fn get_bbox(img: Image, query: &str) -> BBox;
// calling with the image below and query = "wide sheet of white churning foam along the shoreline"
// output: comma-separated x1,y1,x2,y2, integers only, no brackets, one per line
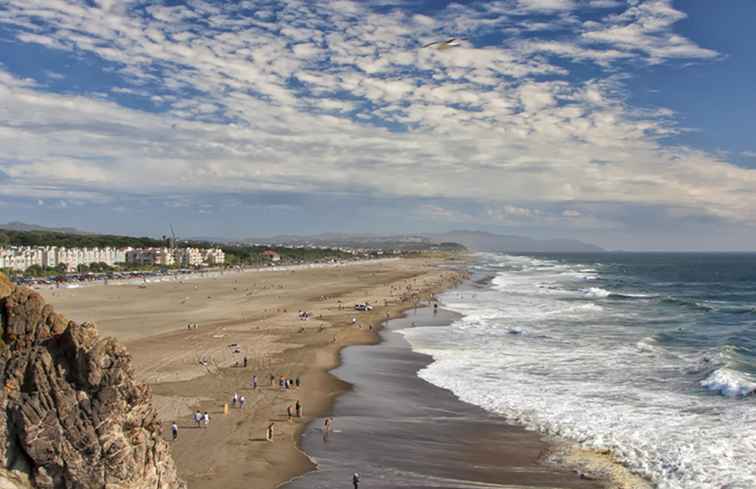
403,257,756,489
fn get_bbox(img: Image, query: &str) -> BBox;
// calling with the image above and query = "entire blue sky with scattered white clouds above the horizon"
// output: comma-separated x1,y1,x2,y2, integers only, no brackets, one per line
0,0,756,250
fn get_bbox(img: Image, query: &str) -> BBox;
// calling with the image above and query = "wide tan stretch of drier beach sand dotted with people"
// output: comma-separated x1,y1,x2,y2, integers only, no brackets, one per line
40,259,460,489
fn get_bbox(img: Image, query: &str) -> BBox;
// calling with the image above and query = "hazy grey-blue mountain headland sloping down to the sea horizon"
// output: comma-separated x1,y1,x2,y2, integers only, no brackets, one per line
425,231,605,253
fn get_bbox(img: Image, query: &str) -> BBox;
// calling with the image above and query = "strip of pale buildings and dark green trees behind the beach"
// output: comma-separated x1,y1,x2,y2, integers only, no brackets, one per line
0,223,464,284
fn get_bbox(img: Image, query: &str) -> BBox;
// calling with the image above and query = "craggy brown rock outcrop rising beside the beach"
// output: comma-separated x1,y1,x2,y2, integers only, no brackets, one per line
0,274,185,489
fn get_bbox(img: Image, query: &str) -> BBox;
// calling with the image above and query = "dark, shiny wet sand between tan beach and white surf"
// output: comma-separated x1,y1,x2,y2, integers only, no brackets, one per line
284,308,603,489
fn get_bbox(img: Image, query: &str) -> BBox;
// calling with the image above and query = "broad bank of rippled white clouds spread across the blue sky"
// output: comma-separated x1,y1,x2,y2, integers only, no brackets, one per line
0,0,756,227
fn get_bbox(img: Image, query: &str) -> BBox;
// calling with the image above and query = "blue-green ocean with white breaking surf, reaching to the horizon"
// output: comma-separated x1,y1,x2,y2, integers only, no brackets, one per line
402,253,756,489
